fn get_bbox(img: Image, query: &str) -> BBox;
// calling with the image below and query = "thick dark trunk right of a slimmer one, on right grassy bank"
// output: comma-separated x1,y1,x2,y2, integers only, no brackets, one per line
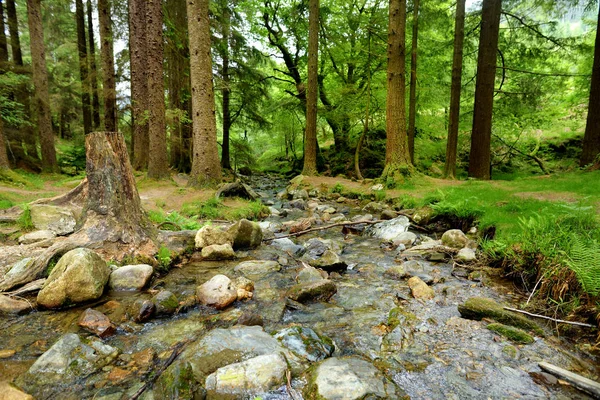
469,0,502,179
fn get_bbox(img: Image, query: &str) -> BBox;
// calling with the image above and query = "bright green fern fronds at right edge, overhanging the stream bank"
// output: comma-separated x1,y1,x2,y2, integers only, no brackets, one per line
567,235,600,296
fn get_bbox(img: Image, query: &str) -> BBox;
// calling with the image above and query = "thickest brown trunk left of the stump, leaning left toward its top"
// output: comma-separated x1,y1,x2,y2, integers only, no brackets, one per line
27,0,58,172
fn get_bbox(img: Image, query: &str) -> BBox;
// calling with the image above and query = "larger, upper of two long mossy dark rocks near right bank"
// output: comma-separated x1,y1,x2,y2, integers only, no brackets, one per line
458,297,544,336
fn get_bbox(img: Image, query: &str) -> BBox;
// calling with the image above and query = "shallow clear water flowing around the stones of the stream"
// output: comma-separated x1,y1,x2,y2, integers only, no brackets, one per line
0,177,597,399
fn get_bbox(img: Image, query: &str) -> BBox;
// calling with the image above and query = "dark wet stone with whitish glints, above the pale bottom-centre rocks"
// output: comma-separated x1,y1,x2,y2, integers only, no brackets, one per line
275,326,335,362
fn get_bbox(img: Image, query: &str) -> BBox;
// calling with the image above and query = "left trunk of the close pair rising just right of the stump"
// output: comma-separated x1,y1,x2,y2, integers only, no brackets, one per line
129,0,150,170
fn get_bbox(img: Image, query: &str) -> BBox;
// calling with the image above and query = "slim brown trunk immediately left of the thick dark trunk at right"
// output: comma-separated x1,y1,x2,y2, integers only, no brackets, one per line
444,0,465,179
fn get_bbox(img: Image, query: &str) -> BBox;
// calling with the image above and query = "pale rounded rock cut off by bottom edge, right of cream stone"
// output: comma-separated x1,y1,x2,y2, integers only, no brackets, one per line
305,357,401,400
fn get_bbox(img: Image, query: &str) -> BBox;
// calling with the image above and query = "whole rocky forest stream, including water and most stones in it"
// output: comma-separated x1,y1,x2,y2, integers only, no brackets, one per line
0,176,598,400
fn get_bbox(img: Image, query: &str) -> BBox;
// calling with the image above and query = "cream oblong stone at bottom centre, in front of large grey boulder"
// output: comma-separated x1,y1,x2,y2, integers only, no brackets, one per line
204,354,287,398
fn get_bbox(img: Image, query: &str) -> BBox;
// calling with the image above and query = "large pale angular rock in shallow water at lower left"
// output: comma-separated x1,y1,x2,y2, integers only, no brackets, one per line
19,333,119,388
